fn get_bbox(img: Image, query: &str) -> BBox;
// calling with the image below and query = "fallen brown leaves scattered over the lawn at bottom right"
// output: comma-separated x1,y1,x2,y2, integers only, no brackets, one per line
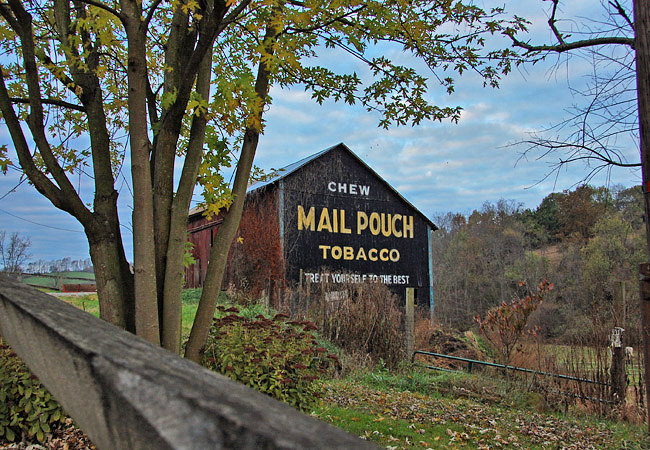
314,379,636,449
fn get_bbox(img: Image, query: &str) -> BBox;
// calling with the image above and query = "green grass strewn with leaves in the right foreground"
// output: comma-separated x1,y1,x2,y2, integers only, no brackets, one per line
312,369,650,449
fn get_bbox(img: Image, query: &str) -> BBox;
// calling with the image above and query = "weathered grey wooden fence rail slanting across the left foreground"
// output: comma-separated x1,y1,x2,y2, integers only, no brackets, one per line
0,277,374,449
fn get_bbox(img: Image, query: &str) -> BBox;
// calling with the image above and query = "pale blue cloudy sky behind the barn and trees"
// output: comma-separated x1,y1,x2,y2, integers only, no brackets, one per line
0,0,641,260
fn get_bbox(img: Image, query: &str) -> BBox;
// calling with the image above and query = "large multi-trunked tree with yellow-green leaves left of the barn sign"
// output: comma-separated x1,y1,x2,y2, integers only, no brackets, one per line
0,0,518,360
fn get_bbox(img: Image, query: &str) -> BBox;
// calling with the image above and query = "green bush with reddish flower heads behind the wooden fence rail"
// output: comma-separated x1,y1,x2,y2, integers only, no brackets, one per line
202,306,338,411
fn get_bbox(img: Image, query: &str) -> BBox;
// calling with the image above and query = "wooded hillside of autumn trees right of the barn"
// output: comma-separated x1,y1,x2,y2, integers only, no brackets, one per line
432,185,647,340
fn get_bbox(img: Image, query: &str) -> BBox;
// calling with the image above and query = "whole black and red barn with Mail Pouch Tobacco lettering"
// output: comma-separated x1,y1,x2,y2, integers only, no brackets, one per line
186,143,436,307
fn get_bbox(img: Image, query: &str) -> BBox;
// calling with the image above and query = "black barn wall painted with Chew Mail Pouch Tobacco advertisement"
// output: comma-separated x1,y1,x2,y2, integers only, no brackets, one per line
281,146,433,297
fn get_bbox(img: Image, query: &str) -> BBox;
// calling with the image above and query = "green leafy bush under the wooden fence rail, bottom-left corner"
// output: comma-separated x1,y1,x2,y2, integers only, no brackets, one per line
0,339,65,443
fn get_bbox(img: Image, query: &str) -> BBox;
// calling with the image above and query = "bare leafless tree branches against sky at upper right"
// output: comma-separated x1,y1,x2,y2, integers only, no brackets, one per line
504,0,641,181
